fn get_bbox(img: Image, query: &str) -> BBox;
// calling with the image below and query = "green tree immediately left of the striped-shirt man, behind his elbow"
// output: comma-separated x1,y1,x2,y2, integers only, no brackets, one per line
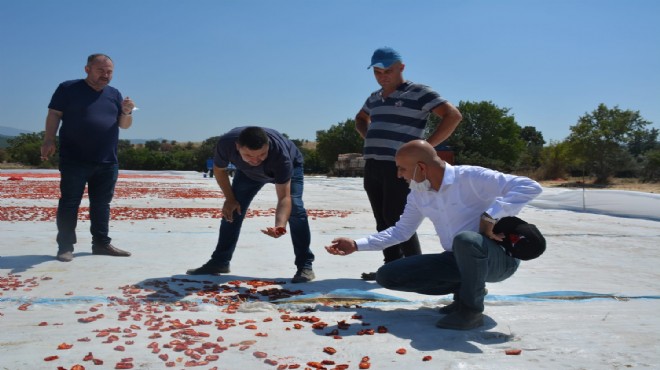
316,119,364,171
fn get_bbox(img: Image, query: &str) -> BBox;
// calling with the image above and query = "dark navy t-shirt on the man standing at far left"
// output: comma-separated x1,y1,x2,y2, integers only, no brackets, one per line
48,80,122,163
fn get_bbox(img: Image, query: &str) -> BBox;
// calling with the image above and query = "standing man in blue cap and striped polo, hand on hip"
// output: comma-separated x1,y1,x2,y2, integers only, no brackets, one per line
355,47,463,280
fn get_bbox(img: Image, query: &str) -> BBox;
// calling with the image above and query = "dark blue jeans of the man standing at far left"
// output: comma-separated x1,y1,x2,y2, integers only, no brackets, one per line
56,158,119,251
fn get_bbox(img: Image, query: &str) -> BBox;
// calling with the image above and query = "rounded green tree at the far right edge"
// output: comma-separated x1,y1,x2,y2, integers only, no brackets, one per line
567,103,657,184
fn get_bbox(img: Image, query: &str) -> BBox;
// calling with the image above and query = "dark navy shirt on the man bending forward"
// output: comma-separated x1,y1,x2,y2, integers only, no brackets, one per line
213,127,303,184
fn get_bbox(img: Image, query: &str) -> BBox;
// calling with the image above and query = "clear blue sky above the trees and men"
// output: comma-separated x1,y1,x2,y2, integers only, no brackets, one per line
0,0,660,142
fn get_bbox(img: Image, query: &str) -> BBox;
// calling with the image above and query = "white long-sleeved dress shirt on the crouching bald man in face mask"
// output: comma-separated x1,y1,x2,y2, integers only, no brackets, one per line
355,163,542,251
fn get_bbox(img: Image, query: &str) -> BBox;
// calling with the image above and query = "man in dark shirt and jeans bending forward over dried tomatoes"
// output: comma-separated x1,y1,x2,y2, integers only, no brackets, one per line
187,127,314,283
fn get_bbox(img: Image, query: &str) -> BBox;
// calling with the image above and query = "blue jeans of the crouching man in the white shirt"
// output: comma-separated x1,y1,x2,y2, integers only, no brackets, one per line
376,231,520,312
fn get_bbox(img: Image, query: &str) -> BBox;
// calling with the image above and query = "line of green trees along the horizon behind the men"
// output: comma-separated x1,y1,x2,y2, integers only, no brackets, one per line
0,101,660,184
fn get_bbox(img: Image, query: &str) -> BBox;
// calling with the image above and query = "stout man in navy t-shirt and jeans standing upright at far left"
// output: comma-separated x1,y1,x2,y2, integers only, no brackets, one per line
41,54,135,262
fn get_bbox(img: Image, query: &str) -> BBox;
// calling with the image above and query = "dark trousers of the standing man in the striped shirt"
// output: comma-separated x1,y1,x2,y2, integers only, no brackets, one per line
364,159,422,263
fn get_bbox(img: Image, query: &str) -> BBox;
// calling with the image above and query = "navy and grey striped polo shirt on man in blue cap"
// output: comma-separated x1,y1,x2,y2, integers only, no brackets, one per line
362,81,447,161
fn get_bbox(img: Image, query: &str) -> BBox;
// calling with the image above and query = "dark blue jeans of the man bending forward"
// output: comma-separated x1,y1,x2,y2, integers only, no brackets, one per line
209,167,314,269
